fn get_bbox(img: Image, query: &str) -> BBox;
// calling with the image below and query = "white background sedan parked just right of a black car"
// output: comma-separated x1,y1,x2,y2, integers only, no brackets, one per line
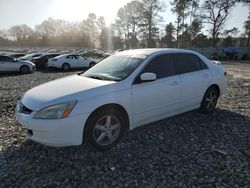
47,54,95,71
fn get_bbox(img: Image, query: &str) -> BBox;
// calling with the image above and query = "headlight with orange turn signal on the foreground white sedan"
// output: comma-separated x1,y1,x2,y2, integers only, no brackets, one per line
33,101,77,119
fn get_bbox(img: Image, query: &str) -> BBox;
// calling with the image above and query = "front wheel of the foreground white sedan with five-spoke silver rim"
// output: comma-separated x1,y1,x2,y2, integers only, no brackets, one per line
83,108,127,152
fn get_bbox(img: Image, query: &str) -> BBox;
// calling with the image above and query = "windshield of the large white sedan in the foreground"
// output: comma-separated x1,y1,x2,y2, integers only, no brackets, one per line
82,55,145,81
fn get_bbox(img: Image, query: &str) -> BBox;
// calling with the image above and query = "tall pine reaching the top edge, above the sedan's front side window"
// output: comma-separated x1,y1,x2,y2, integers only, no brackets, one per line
140,0,165,48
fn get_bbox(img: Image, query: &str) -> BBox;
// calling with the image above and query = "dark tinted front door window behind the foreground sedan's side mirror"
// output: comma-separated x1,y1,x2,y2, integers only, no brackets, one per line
142,55,175,79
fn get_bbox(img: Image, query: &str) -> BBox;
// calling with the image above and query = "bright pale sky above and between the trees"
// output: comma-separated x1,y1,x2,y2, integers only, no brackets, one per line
0,0,249,34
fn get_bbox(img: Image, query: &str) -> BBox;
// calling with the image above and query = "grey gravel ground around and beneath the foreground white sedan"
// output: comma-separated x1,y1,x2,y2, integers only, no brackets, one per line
0,64,250,188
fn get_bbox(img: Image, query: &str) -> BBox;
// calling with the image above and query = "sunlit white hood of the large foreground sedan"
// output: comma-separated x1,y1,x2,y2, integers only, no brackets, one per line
21,75,117,111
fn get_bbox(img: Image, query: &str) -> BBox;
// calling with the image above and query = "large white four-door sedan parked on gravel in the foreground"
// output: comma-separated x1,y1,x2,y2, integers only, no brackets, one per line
16,49,227,151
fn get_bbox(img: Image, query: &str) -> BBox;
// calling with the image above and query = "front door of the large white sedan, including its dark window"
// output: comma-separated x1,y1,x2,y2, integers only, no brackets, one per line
132,54,181,126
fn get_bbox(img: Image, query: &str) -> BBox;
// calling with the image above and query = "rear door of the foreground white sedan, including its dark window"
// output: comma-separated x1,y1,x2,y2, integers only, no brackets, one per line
174,53,211,108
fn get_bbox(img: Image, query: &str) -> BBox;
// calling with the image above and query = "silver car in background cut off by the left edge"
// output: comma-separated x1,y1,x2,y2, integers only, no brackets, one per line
0,55,35,74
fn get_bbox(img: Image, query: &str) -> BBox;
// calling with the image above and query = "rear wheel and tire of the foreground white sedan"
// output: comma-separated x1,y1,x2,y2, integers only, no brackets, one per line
200,86,219,114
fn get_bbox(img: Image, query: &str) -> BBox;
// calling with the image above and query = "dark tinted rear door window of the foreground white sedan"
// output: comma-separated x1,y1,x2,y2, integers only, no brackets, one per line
174,54,202,74
